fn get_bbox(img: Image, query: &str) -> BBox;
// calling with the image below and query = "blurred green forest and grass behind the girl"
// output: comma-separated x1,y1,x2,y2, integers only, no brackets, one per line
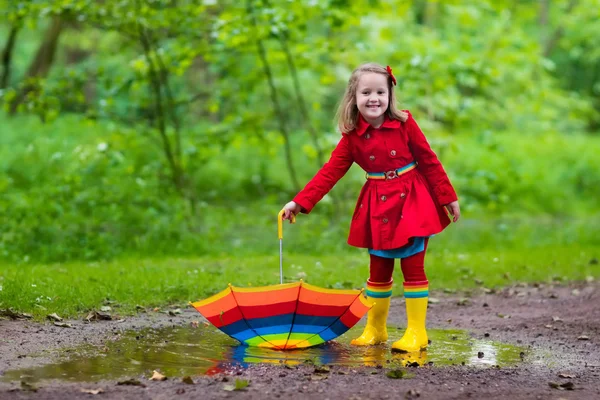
0,0,600,318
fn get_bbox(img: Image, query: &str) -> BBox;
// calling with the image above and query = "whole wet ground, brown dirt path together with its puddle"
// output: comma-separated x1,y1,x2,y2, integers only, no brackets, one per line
0,282,600,399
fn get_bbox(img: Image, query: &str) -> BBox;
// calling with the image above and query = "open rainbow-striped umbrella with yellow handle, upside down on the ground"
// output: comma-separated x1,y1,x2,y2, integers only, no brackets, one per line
191,210,372,350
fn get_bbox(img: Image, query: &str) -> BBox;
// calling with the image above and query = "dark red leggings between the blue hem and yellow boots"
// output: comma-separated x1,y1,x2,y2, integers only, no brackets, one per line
369,239,429,282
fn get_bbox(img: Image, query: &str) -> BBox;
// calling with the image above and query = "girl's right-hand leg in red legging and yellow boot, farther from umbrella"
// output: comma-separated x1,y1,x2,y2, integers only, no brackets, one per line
392,239,429,352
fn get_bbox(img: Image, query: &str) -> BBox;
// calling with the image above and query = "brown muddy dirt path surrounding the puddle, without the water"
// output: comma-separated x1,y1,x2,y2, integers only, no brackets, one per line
0,282,600,400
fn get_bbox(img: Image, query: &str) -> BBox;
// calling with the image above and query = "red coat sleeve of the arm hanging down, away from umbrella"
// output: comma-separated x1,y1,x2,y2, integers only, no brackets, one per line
406,113,458,205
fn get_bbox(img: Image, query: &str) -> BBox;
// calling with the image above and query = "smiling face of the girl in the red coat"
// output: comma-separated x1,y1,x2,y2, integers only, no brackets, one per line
356,72,390,128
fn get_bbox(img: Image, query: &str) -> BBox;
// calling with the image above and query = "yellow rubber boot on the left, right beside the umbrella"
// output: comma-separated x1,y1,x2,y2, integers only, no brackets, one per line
350,281,392,346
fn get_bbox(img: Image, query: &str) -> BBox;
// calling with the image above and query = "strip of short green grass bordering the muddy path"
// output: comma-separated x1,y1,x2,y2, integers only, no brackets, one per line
0,243,600,318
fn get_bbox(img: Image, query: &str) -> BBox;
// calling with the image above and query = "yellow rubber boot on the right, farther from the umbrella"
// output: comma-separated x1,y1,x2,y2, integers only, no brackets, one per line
392,281,429,353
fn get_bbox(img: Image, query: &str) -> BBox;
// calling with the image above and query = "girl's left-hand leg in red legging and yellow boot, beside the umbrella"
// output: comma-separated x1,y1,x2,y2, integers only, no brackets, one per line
352,254,394,346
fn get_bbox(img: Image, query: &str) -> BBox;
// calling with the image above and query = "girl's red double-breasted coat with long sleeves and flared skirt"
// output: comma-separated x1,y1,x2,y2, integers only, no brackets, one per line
294,113,457,250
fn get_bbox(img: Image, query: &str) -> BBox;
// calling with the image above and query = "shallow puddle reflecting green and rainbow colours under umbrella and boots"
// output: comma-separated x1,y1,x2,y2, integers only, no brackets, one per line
0,326,525,382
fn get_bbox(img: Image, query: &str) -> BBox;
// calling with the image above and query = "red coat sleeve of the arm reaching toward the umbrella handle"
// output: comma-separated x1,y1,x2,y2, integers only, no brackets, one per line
294,134,354,214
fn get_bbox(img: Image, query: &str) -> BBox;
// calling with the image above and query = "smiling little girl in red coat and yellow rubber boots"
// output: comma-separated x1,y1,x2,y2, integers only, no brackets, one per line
283,63,460,352
